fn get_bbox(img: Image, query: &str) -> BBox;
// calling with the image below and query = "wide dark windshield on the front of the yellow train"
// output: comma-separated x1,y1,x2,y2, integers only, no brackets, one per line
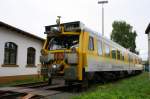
48,35,79,50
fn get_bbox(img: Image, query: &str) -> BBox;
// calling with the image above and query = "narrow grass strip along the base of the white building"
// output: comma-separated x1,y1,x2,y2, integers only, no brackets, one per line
0,77,43,87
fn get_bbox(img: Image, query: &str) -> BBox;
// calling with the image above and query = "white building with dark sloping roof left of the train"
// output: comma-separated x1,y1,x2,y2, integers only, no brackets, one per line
0,21,44,83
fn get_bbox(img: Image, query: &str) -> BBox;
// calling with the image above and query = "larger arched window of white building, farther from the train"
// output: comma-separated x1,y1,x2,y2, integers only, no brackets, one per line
4,42,17,65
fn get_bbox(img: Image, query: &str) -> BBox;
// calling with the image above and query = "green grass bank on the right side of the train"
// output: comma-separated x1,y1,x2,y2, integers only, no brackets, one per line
73,72,150,99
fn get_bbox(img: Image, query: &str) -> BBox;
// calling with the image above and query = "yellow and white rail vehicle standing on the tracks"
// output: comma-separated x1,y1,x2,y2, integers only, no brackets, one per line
40,21,143,83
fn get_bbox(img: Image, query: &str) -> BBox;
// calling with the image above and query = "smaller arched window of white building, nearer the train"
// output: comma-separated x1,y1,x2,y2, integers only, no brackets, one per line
27,47,35,66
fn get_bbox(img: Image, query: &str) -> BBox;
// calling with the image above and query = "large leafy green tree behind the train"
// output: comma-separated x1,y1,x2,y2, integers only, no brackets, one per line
111,21,138,54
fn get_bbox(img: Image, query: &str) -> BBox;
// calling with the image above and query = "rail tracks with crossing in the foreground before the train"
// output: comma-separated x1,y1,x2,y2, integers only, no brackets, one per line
0,81,79,99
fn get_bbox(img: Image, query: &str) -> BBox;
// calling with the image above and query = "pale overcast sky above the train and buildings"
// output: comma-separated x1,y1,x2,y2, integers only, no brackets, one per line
0,0,150,59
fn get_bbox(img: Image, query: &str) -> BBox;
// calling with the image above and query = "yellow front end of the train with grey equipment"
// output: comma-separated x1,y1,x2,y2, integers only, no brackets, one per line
40,21,84,84
